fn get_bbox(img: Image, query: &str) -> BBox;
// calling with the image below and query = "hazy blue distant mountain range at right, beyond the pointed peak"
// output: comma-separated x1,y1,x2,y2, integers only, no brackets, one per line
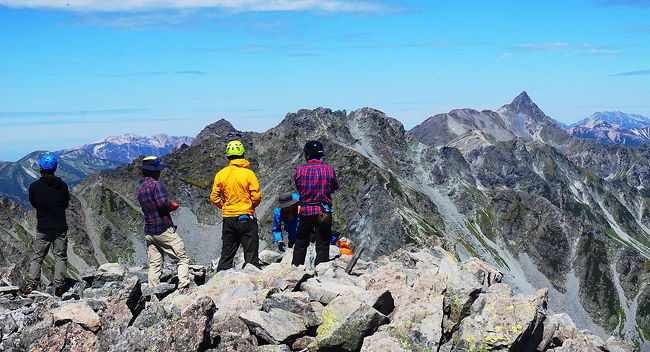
555,111,650,147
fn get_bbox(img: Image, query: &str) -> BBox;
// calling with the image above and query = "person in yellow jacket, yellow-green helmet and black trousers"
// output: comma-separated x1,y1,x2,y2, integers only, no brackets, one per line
210,141,262,271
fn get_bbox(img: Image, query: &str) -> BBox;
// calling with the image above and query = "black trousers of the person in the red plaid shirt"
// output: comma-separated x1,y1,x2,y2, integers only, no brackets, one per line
291,215,332,266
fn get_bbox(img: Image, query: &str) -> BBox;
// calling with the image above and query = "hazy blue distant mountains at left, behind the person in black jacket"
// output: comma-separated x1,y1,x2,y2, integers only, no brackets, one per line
0,134,194,208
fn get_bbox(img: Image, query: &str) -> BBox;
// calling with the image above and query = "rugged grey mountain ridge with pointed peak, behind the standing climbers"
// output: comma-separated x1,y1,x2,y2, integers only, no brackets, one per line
0,94,650,346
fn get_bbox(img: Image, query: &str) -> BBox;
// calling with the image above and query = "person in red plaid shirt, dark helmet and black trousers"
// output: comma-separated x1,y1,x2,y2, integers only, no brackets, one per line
291,141,339,266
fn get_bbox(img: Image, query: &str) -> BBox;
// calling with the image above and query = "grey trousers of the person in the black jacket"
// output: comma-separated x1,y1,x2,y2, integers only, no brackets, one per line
27,232,68,286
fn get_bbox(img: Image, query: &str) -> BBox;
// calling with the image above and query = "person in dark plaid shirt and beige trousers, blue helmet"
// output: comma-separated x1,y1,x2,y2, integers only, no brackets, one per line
138,156,190,293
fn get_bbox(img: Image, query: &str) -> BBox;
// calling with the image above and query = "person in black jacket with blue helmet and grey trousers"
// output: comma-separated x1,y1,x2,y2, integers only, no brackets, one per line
21,154,70,297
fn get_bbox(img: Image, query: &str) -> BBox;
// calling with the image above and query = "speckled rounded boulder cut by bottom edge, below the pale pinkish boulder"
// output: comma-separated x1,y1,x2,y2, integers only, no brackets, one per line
30,323,99,352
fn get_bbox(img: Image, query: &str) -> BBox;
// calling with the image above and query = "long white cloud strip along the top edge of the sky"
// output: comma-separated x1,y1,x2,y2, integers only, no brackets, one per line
0,0,392,13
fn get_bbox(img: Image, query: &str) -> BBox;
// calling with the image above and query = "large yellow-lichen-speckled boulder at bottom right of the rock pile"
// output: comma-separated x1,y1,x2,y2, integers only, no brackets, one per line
453,283,548,351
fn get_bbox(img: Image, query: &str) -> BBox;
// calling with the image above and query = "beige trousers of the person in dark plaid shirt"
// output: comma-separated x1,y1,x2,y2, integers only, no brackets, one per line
144,227,190,288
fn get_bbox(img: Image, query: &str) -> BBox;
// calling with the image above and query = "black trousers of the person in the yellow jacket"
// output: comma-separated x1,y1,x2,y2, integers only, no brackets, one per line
217,218,260,271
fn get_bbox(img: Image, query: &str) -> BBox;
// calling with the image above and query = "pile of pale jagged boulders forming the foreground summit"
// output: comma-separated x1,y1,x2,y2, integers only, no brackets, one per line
0,246,634,352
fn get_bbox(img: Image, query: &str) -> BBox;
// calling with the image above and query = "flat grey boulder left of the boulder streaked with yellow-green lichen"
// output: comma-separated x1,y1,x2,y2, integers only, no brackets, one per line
239,308,307,344
